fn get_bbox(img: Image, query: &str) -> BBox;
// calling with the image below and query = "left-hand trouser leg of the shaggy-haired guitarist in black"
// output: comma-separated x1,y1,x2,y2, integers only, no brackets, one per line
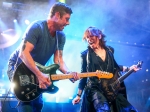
80,89,111,112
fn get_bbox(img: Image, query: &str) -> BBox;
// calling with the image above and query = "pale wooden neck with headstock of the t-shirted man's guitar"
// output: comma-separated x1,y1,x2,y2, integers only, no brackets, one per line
51,72,112,80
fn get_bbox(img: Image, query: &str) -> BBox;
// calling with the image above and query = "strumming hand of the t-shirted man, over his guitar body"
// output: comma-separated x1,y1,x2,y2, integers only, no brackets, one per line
38,73,52,89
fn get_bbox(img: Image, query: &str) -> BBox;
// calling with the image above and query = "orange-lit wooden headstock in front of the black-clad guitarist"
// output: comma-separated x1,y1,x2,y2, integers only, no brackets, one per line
96,70,113,79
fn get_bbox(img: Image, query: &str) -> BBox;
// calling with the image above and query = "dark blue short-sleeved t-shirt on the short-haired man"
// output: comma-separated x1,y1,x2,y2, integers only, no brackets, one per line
9,21,66,66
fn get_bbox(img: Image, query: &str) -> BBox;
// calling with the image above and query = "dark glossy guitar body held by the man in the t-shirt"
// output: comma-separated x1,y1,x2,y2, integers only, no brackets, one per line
12,63,59,102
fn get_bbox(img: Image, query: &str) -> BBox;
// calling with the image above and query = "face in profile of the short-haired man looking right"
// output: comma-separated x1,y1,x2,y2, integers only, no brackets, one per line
57,13,70,30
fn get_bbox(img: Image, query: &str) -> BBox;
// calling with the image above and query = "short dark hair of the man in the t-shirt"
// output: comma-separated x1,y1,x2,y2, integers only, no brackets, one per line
49,2,73,17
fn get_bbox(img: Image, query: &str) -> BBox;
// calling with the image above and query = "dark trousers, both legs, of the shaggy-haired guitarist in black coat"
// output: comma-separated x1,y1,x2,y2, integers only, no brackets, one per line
80,89,137,112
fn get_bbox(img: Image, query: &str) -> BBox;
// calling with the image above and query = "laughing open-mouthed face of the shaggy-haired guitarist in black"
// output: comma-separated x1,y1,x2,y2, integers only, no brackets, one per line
86,35,99,49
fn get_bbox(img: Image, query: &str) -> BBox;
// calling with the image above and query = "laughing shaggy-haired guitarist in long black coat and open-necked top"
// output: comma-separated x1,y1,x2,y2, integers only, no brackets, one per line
72,27,140,112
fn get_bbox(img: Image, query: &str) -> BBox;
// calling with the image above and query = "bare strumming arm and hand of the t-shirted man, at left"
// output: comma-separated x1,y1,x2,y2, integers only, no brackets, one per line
19,41,51,89
